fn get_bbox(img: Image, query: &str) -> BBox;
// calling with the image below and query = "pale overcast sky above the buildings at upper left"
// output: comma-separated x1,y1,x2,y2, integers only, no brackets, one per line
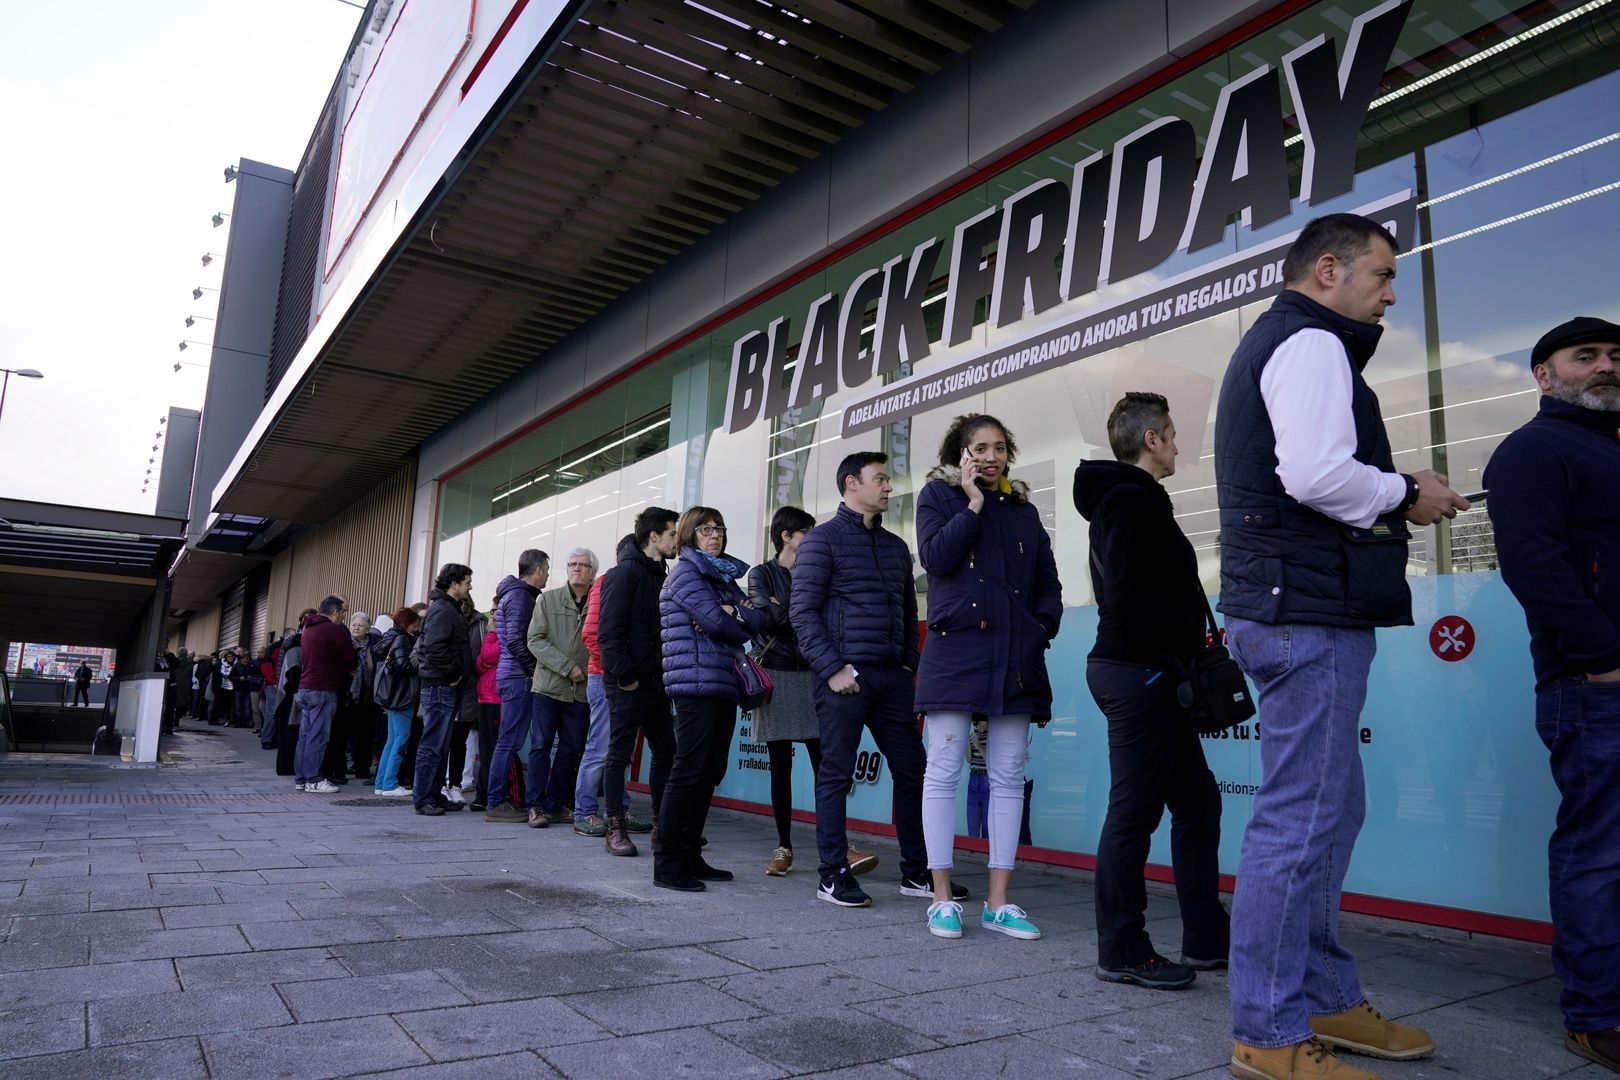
0,0,360,512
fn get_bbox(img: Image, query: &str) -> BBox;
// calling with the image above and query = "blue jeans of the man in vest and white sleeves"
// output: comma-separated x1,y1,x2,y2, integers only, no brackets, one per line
1226,619,1377,1048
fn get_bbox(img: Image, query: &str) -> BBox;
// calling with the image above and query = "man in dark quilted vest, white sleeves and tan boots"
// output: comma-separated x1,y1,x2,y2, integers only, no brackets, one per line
1215,214,1468,1080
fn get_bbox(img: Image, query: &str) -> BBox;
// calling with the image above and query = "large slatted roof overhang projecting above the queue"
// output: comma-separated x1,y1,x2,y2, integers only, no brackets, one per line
211,0,1035,523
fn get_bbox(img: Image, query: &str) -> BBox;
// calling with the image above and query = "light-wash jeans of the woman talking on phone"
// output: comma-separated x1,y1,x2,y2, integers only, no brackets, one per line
922,712,1029,870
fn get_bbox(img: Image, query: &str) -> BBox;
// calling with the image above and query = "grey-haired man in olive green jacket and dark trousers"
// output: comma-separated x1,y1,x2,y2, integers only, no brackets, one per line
527,547,596,829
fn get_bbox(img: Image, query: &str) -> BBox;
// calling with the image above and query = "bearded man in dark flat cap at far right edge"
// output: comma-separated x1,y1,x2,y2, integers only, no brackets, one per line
1486,316,1620,1072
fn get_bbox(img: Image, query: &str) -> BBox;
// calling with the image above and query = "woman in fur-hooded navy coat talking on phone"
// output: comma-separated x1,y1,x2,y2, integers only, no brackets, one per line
917,416,1063,939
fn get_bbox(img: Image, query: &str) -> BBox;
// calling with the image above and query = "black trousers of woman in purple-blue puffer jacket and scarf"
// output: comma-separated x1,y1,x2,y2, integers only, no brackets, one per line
654,698,737,878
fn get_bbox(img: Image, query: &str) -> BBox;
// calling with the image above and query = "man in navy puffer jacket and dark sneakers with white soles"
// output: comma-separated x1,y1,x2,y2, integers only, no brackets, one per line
787,452,933,907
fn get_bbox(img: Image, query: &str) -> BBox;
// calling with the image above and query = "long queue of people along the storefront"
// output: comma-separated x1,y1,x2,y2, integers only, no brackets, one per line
180,214,1620,1080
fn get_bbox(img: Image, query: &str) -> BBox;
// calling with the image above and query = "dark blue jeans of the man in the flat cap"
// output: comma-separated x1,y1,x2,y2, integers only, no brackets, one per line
1536,678,1620,1031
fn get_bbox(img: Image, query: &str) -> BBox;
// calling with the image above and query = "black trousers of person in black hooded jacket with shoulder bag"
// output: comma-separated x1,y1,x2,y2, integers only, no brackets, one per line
1085,661,1231,967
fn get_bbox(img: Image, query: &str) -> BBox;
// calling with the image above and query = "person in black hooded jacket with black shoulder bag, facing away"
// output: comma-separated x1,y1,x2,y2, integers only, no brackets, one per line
1074,393,1230,989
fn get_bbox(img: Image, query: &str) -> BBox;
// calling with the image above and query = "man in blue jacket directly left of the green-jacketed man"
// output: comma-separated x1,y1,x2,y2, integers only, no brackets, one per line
484,547,551,829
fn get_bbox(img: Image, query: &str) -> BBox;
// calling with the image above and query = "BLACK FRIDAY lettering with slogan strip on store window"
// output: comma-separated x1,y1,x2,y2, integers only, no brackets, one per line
726,0,1411,434
